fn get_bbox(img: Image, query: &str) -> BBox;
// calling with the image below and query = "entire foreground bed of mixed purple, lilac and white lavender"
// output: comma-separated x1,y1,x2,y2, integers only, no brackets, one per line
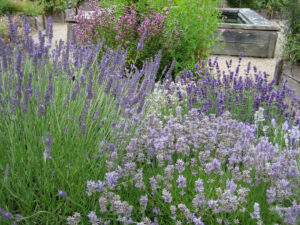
0,17,300,225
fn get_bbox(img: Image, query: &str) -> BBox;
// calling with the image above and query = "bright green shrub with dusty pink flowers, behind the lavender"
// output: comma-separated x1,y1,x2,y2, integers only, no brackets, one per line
74,0,220,75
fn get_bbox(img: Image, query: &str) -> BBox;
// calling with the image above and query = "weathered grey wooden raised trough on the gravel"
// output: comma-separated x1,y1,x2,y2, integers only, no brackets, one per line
212,8,279,58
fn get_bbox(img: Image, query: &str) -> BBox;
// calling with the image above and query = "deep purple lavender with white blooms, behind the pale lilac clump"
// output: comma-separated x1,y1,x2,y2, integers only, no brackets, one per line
151,56,300,149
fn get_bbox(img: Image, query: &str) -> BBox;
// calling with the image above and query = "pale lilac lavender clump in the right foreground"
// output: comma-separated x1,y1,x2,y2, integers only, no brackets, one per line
84,108,300,224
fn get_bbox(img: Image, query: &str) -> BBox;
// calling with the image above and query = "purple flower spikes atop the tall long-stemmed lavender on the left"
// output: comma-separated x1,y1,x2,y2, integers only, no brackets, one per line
0,16,161,125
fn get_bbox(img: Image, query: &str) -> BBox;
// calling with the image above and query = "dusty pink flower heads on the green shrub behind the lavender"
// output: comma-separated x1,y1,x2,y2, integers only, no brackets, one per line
73,0,168,47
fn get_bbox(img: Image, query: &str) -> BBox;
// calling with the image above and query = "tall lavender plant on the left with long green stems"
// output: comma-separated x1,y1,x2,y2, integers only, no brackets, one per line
0,17,161,224
